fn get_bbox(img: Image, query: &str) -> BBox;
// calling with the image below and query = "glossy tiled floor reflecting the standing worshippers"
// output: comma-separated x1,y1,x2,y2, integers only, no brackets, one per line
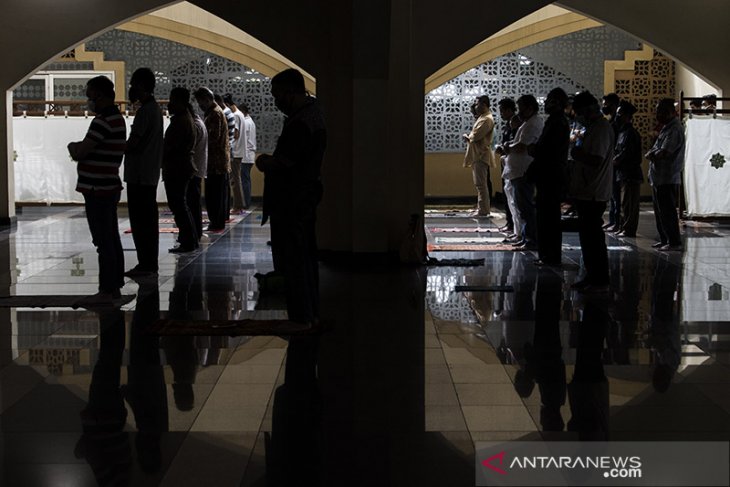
0,207,730,487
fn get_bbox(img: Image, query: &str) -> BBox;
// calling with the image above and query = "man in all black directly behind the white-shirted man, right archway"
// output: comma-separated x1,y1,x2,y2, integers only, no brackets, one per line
528,88,570,266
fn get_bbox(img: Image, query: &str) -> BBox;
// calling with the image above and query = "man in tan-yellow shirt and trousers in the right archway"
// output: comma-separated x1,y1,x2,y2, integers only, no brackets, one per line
463,95,494,217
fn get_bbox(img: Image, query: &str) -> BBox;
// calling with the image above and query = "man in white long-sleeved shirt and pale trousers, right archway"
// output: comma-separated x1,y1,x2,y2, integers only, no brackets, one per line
502,95,543,250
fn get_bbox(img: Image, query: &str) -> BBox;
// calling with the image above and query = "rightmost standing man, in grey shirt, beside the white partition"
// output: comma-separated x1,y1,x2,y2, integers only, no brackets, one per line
646,98,685,251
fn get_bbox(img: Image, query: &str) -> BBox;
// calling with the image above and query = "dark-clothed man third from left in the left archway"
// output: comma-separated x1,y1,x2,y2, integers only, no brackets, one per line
162,87,198,254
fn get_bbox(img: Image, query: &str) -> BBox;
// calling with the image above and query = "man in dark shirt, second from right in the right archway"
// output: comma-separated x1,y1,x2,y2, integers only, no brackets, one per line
613,100,644,237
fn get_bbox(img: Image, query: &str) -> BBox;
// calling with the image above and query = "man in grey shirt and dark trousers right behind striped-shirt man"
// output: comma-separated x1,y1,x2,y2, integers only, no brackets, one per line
124,68,163,277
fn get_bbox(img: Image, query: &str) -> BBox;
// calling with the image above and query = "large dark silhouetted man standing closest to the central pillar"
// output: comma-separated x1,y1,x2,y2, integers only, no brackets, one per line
256,69,327,324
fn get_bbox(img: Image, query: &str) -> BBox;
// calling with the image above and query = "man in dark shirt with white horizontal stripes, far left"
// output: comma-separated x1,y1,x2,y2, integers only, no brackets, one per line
68,76,127,306
